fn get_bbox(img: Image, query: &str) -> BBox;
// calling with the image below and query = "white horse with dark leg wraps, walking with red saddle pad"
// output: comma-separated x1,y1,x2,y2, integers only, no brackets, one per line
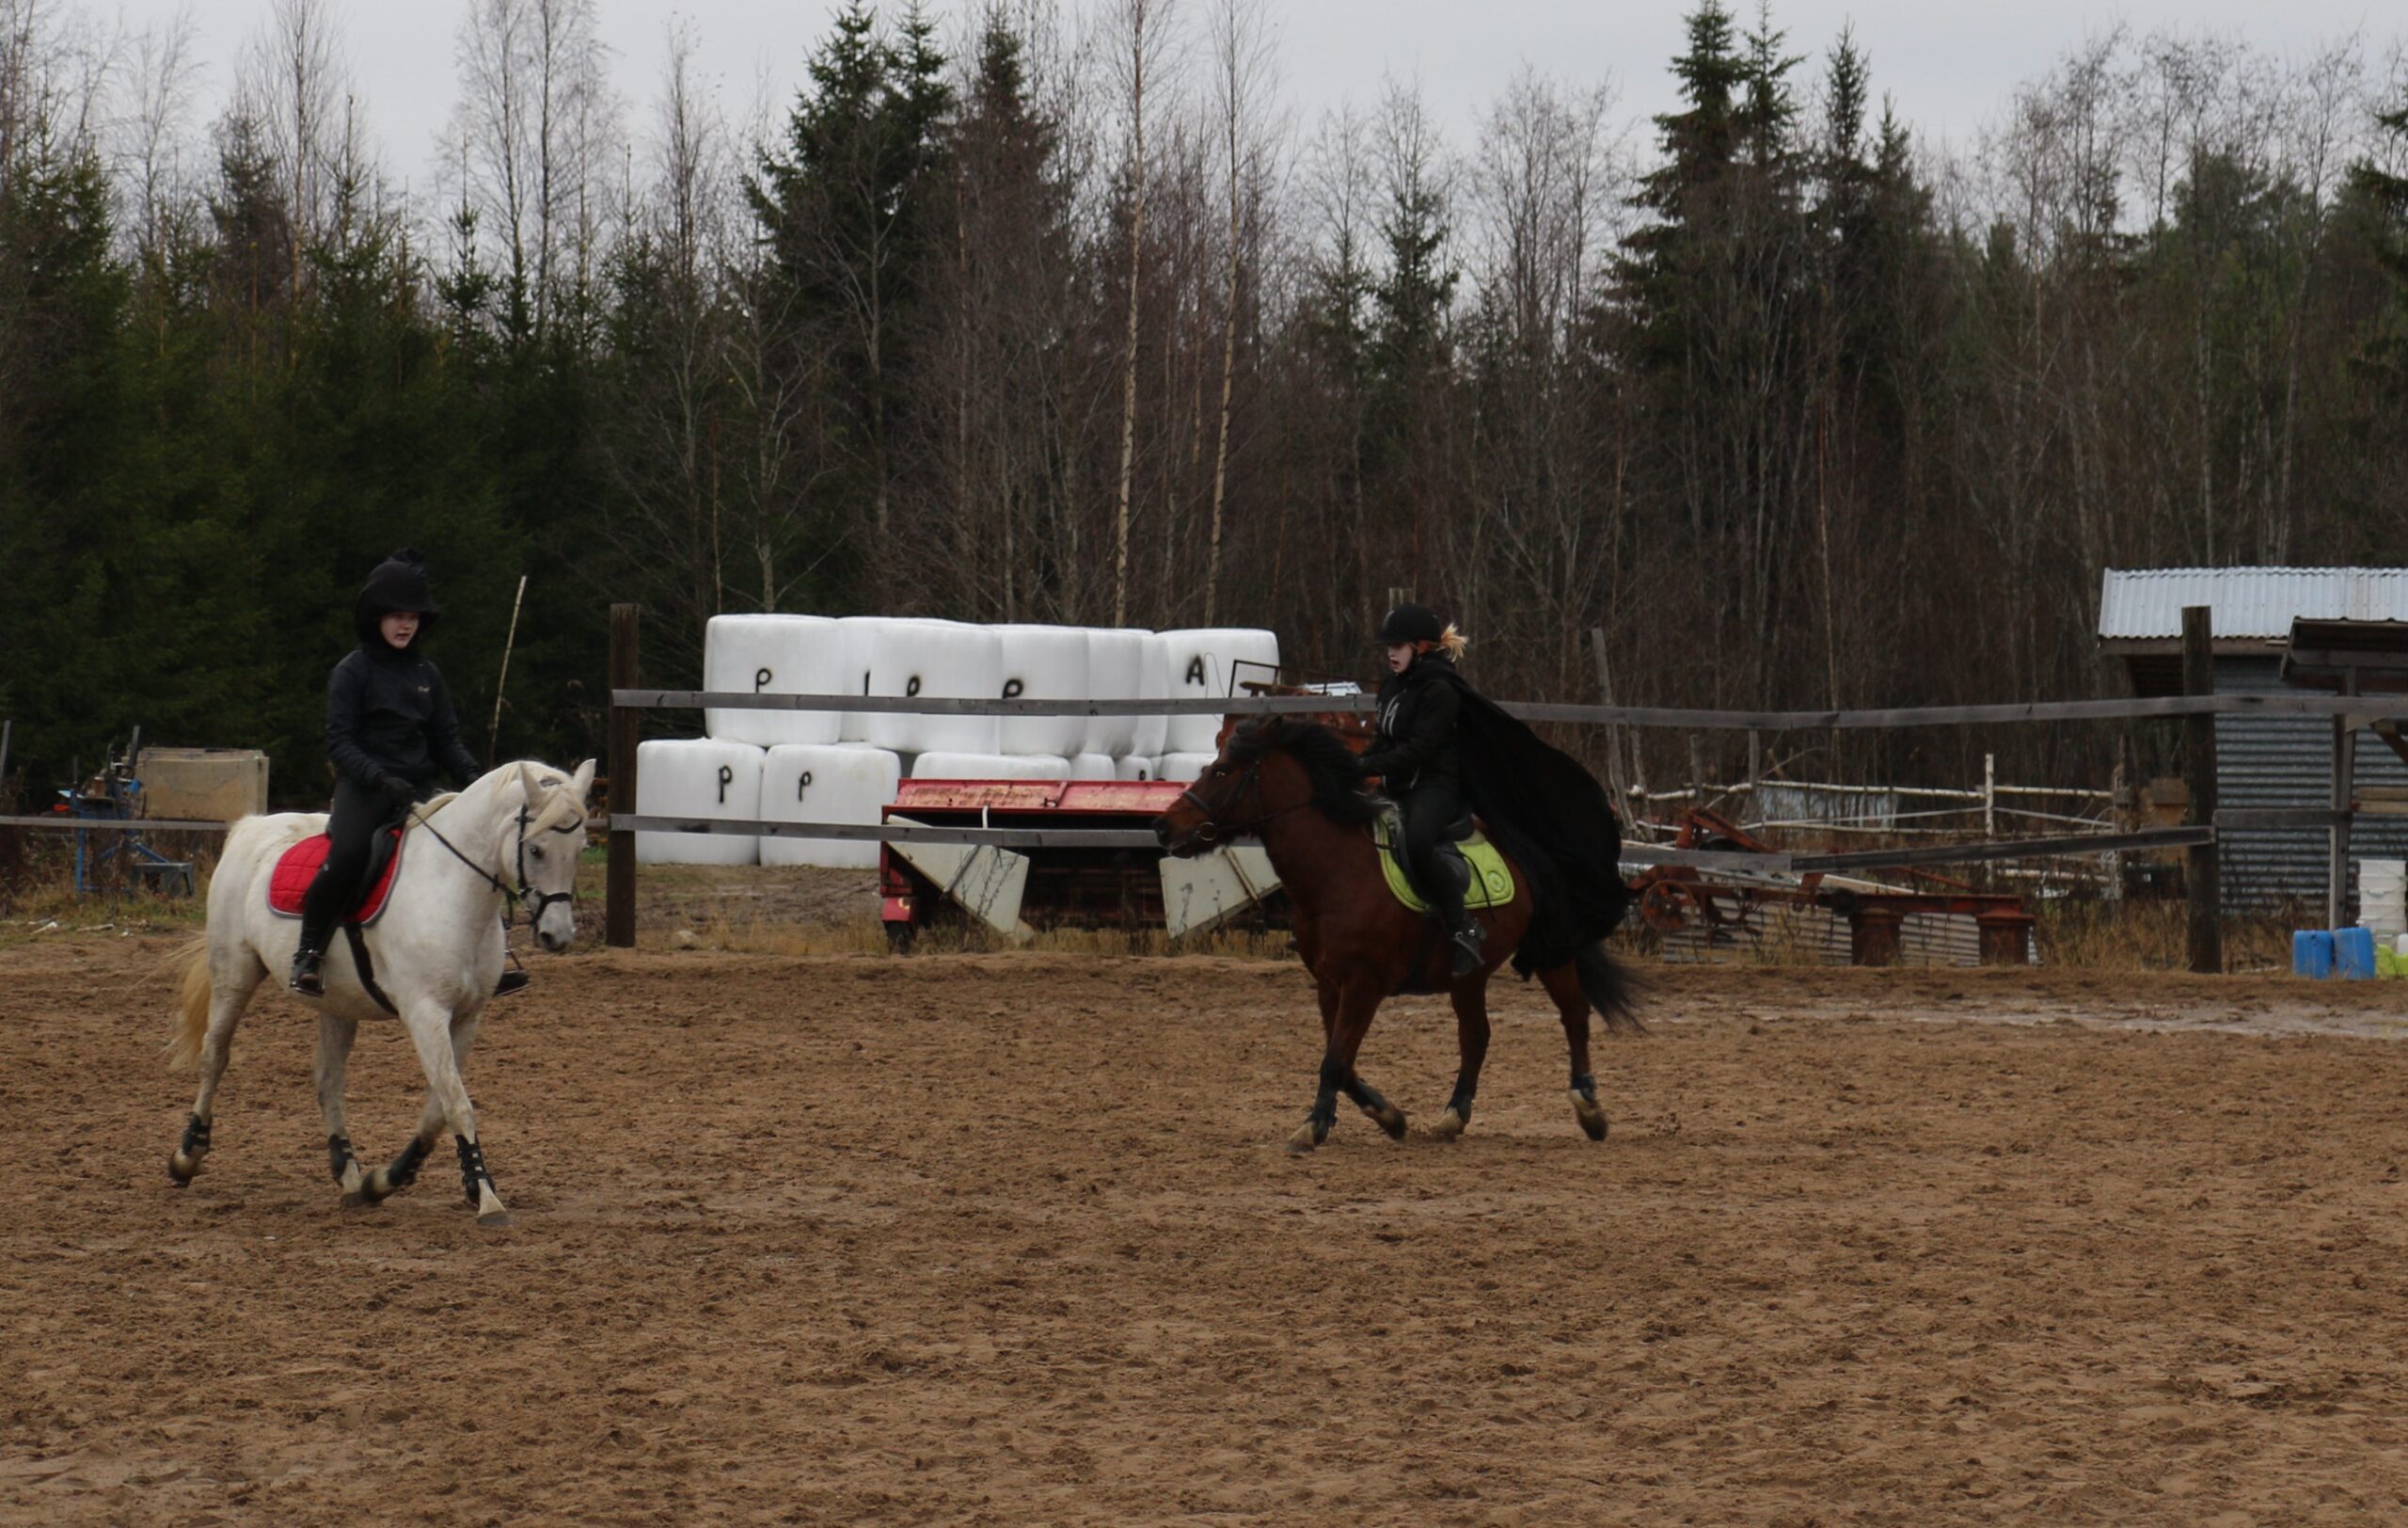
166,759,594,1227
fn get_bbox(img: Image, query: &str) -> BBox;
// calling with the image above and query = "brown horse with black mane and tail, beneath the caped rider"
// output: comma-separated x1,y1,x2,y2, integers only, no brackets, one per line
1153,718,1640,1152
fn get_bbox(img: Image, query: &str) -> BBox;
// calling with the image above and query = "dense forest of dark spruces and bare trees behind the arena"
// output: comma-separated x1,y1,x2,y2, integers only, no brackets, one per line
0,0,2408,803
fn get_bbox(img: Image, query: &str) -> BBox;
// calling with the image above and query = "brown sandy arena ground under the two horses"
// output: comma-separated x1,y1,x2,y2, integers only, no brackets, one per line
0,935,2408,1525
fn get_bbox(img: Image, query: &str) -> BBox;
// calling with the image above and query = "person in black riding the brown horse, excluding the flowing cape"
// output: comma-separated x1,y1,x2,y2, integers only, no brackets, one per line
1363,605,1486,976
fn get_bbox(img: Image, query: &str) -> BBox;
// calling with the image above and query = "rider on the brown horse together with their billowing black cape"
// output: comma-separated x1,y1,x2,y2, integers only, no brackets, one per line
1363,605,1630,976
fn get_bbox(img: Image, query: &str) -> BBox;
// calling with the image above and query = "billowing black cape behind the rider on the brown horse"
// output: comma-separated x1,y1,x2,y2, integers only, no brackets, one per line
1431,662,1630,976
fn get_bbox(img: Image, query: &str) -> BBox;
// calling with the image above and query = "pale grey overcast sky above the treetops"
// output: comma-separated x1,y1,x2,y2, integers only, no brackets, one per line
103,0,2403,185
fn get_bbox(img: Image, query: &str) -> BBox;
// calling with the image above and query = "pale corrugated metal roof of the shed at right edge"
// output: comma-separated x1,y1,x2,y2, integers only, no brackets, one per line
2099,569,2408,641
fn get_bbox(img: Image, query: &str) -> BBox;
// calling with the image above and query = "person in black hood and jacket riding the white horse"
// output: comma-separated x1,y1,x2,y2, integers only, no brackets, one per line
292,547,484,997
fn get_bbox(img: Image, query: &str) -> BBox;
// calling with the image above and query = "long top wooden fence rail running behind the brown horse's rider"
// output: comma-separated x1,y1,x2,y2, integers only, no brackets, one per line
611,687,2408,733
